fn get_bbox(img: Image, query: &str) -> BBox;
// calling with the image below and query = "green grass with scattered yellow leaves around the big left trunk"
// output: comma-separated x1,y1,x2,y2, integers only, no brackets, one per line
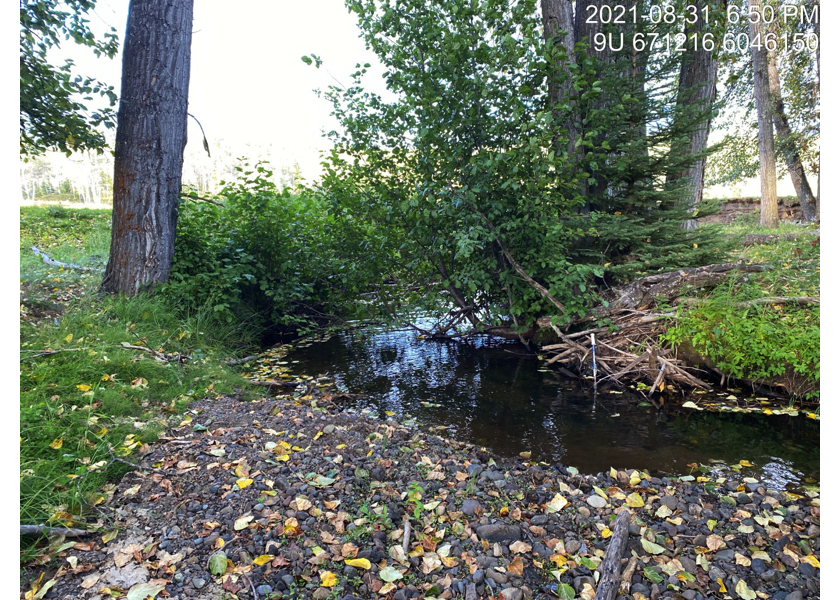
20,207,262,561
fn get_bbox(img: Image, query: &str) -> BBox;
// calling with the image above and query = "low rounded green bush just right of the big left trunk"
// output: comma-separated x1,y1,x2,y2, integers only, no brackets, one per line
169,164,372,332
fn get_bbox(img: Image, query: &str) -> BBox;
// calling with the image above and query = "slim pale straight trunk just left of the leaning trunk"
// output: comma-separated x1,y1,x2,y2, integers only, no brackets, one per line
749,0,779,227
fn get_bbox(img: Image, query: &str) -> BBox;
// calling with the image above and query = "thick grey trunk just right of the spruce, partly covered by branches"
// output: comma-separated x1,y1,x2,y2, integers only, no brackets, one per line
676,0,720,229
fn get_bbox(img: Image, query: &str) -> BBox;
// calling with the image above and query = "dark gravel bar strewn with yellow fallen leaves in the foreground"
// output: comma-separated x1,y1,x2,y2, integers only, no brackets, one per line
26,395,820,600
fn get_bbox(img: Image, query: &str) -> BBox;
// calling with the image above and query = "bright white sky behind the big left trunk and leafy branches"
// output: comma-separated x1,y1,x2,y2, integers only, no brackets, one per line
62,0,384,178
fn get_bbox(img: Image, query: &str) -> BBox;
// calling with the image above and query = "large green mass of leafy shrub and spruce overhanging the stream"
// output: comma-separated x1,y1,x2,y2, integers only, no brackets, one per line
314,0,717,329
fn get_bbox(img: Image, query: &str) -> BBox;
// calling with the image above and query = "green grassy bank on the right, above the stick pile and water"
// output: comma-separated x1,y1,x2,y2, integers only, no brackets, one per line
667,215,820,400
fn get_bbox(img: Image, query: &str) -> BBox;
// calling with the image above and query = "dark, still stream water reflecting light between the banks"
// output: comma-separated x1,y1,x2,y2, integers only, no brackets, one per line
287,328,820,487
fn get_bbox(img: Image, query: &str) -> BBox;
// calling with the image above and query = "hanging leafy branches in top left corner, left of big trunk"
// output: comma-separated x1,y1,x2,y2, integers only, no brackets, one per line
20,0,119,155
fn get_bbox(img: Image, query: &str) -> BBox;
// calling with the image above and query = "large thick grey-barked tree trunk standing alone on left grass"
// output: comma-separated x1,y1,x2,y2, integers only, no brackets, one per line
102,0,193,295
